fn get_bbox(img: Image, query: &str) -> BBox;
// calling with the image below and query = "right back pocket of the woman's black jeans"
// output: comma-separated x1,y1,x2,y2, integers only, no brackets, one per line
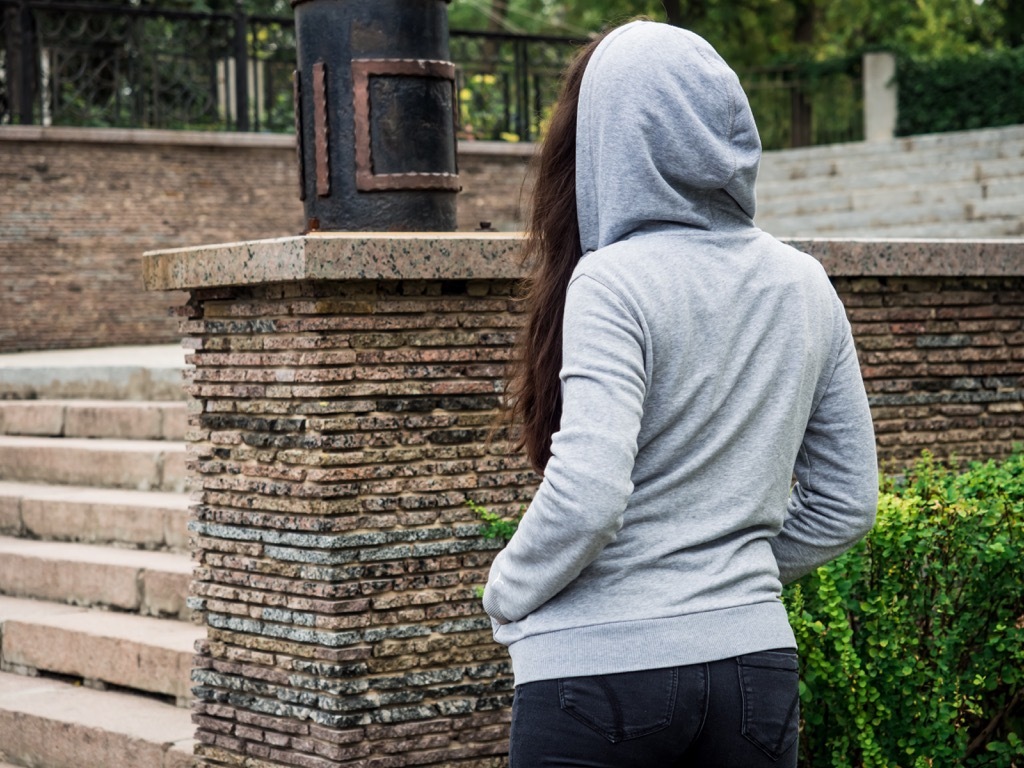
736,650,800,760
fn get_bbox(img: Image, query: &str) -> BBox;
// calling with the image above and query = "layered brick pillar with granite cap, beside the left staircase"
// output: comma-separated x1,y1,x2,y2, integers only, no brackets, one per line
145,234,535,768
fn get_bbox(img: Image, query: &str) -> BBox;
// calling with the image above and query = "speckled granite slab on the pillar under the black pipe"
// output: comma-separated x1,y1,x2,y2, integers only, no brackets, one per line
142,232,523,291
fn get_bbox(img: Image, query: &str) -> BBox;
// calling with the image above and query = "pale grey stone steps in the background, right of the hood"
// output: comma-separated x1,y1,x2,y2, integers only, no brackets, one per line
757,126,1024,238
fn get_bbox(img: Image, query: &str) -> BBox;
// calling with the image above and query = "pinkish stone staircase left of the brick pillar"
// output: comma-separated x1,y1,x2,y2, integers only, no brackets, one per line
0,347,198,768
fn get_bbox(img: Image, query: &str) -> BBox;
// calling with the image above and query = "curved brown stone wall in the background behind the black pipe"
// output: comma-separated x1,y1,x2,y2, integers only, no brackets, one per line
0,126,531,353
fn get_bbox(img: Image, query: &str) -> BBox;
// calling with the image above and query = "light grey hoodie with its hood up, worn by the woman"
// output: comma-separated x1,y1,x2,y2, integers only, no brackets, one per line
483,22,878,684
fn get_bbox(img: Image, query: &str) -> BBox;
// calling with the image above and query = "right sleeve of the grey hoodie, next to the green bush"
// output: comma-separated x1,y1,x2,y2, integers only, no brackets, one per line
772,297,879,584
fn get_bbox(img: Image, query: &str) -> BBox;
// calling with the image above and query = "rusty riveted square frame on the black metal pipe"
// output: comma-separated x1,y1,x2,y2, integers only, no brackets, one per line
352,58,461,191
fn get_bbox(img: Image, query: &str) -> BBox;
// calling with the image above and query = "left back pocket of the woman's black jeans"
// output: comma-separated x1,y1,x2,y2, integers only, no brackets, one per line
558,669,679,743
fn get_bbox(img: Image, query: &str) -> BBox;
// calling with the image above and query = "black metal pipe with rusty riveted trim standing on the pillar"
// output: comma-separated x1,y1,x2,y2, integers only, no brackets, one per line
292,0,459,231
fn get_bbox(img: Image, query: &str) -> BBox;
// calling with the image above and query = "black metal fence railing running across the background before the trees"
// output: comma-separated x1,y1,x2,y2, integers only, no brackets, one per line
0,0,862,148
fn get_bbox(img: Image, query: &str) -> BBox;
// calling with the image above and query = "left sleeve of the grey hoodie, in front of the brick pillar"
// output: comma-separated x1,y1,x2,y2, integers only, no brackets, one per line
483,275,646,624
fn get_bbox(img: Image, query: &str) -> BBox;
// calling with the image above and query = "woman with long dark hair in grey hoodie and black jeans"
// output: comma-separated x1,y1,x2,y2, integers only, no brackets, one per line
483,22,878,768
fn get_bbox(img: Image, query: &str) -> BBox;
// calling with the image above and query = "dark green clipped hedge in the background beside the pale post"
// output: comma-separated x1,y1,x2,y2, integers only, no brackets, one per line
896,48,1024,136
